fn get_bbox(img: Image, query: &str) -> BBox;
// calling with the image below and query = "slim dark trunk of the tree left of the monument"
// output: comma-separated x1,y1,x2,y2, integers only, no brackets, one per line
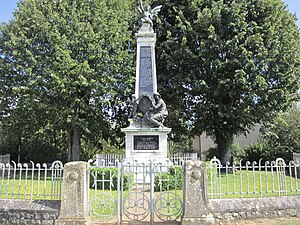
68,129,81,162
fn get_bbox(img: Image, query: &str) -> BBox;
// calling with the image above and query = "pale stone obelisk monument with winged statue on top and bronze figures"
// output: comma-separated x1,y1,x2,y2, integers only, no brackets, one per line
122,1,171,162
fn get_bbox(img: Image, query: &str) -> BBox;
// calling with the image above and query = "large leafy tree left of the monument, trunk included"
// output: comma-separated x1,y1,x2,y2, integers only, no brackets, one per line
0,0,134,161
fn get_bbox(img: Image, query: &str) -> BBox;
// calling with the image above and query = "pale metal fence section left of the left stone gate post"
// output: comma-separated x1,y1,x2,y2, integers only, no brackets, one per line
0,161,63,200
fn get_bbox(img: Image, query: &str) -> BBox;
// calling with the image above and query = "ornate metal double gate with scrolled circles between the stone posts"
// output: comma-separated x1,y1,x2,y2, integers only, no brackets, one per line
89,159,183,224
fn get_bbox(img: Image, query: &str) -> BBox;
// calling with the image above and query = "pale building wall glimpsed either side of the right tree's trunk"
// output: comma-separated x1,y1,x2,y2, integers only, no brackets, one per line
193,124,261,160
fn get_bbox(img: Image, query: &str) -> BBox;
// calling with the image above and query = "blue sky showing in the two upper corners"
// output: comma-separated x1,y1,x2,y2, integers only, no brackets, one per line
0,0,300,25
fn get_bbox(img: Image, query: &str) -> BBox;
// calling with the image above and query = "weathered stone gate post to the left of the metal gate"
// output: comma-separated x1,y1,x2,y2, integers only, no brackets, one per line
55,162,89,225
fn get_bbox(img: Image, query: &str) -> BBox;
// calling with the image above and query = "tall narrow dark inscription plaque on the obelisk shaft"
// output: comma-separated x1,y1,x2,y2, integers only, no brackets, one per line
139,46,153,95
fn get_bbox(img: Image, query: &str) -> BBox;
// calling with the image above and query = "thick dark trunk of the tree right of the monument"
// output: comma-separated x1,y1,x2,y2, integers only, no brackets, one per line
215,133,233,165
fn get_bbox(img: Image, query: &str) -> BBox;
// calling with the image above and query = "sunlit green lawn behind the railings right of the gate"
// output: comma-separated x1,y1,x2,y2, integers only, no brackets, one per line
208,170,300,198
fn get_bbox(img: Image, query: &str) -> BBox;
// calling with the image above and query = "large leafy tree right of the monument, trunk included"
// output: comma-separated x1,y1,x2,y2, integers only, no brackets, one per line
152,0,300,163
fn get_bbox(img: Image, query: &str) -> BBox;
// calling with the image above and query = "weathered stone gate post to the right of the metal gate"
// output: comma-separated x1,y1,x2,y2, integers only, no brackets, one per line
182,161,215,225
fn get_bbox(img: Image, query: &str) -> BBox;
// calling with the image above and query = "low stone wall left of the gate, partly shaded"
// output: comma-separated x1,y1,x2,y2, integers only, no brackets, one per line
0,199,60,225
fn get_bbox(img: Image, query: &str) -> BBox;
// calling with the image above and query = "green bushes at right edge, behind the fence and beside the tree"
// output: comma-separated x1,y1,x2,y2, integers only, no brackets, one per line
235,107,300,162
